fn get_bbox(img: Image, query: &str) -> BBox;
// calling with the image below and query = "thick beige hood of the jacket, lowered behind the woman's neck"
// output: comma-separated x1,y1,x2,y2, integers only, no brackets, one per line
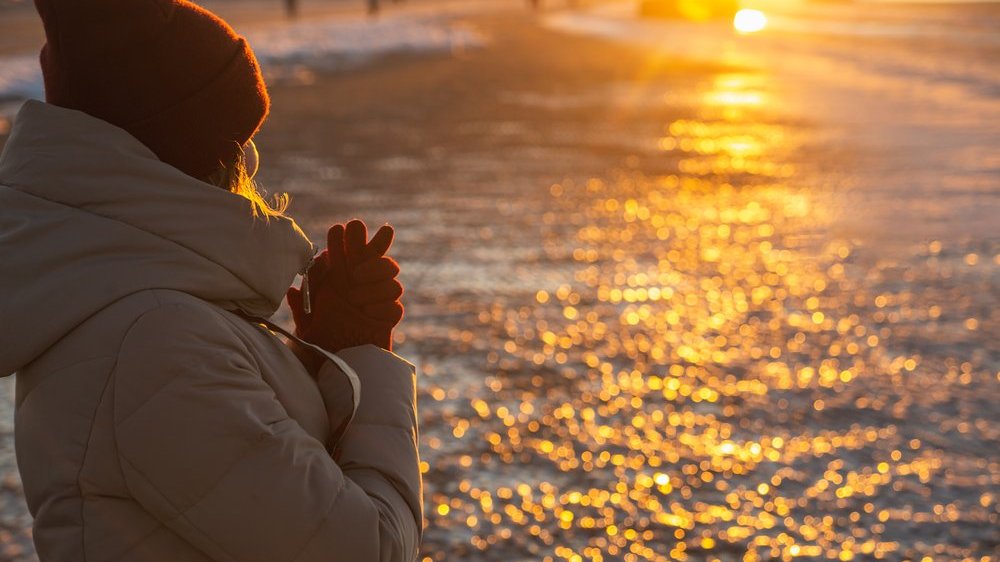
0,101,313,376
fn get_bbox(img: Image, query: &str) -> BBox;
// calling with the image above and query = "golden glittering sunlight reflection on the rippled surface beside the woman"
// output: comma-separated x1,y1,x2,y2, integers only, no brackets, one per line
425,74,1000,562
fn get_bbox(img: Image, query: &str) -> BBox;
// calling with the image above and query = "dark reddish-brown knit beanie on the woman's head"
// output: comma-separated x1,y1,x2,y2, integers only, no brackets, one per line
35,0,270,179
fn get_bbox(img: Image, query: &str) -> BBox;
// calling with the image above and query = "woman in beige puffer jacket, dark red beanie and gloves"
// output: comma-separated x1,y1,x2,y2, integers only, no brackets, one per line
0,0,422,562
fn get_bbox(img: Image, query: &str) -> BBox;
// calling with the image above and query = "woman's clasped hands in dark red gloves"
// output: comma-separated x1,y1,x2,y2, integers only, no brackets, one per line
286,219,403,352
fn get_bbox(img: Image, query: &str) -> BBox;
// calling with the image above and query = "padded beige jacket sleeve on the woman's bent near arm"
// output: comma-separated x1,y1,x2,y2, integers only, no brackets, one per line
113,305,421,562
